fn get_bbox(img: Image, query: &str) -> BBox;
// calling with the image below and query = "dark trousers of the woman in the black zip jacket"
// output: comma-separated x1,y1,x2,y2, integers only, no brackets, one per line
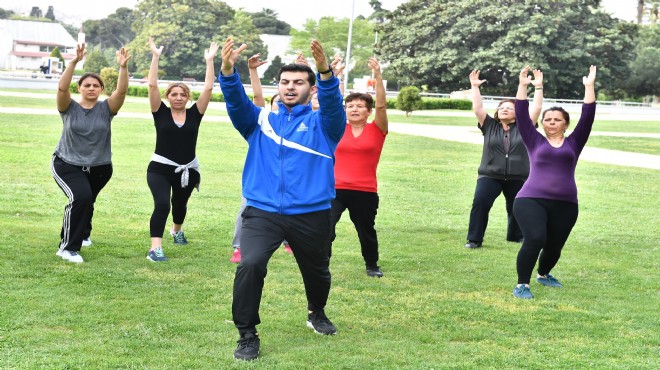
467,177,525,242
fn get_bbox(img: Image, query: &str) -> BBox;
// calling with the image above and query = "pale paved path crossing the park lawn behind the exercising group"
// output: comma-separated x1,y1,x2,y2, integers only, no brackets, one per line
0,102,660,170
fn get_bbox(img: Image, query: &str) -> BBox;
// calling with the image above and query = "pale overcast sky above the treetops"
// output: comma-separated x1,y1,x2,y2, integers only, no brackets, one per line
0,0,637,29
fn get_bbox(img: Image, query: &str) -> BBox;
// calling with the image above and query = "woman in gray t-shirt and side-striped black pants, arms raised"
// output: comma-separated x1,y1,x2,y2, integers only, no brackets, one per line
51,43,130,263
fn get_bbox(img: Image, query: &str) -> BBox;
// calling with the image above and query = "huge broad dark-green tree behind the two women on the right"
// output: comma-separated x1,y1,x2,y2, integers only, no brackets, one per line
377,0,634,98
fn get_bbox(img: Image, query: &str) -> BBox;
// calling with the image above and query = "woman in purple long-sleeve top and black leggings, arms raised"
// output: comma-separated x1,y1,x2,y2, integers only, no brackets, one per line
513,66,596,299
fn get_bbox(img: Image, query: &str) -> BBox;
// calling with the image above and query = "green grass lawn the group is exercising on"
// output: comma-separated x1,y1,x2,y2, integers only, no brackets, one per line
0,97,660,369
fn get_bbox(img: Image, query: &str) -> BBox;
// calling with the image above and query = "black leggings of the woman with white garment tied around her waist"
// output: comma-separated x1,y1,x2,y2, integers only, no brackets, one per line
147,170,200,238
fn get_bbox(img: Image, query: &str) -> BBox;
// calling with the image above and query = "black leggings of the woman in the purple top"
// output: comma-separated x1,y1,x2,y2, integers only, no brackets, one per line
513,198,578,284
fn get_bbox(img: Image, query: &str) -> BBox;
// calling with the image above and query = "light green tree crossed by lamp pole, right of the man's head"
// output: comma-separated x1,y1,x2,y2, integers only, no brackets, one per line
290,17,375,78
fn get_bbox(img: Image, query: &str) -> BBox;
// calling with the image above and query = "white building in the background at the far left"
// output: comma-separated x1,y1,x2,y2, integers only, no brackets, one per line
0,19,76,70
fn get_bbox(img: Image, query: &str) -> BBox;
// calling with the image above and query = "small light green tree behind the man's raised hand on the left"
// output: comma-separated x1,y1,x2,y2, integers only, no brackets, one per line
220,10,268,83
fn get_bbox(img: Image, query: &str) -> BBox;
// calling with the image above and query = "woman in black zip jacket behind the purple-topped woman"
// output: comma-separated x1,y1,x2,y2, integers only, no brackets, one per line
465,70,543,248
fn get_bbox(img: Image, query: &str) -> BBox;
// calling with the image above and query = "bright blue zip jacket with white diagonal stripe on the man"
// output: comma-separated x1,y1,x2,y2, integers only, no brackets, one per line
218,70,346,215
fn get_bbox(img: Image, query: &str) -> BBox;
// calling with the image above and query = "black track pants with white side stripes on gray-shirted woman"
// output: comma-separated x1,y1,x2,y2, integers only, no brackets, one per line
51,156,112,251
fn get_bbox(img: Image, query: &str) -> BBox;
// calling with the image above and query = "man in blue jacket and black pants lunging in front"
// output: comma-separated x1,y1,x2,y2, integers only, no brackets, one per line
218,39,346,360
